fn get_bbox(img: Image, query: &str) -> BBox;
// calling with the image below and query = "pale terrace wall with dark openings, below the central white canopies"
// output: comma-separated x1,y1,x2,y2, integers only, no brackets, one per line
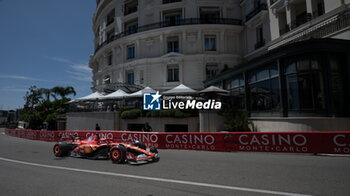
120,117,199,132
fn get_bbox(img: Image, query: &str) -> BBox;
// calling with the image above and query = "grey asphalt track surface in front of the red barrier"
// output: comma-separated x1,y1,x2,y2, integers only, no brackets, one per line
0,130,350,196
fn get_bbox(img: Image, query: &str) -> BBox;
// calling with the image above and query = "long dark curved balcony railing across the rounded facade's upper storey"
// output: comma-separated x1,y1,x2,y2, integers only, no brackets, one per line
95,18,242,53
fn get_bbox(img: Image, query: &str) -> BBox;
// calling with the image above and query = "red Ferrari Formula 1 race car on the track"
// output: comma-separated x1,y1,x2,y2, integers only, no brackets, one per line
53,134,159,163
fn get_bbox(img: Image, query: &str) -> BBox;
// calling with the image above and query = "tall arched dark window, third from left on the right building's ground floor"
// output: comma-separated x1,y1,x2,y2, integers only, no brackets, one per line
284,59,325,111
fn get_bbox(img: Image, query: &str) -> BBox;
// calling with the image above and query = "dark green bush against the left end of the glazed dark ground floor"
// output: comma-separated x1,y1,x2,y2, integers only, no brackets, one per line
222,108,251,132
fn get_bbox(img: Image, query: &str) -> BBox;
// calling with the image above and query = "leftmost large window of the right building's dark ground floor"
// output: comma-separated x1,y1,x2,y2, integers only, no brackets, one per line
224,74,245,109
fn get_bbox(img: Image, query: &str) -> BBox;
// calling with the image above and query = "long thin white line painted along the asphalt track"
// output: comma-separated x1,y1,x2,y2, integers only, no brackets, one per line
0,157,312,196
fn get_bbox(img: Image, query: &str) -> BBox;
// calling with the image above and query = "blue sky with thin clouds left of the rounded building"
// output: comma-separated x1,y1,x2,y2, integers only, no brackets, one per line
0,0,96,110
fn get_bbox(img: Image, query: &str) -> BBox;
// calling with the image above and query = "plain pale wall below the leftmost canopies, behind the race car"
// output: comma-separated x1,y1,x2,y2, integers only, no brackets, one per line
66,112,119,130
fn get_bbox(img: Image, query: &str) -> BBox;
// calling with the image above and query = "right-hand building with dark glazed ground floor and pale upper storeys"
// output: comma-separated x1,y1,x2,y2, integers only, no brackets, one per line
204,0,350,131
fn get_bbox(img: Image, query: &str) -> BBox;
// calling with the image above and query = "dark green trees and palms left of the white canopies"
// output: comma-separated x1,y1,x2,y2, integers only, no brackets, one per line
20,86,75,130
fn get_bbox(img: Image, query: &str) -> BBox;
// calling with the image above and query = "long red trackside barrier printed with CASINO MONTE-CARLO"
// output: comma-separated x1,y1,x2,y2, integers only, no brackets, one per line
5,129,350,154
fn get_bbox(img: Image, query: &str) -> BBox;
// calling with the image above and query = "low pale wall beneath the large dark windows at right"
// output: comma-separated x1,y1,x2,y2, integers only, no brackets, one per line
251,117,350,132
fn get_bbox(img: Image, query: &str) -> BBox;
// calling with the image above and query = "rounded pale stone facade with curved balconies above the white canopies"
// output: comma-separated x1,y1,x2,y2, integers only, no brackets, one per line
89,0,243,92
